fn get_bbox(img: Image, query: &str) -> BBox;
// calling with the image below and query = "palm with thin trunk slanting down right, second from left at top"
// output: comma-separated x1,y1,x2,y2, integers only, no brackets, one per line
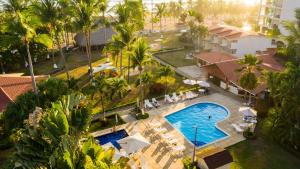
34,0,70,80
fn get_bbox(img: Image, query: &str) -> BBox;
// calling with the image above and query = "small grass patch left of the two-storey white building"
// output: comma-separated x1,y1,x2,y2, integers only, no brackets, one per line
155,50,197,67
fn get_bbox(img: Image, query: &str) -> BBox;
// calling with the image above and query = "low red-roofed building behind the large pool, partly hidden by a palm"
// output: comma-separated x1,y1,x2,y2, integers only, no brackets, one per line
195,48,283,97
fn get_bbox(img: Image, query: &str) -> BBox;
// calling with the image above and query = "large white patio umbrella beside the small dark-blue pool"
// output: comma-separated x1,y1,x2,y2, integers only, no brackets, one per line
117,133,150,154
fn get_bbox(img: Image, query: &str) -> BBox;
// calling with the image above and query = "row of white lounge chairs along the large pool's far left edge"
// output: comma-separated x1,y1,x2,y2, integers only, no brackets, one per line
144,91,198,108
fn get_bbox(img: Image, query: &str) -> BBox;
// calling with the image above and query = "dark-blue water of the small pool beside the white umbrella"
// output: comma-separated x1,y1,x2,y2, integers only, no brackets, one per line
96,130,128,150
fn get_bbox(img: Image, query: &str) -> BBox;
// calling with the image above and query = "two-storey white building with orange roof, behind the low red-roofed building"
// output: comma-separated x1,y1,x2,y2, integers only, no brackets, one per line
204,25,272,57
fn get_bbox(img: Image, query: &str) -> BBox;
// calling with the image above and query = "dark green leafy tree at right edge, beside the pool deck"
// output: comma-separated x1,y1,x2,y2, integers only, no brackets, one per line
267,63,300,151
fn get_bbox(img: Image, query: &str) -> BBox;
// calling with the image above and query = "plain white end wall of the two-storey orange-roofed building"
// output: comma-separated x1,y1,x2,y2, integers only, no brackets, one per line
231,36,272,57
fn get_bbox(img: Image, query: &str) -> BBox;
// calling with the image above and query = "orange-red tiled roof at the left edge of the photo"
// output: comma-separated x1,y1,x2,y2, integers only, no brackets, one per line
0,75,45,111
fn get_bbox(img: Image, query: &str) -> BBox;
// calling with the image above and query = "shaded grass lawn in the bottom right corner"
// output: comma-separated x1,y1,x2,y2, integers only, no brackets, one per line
228,120,300,169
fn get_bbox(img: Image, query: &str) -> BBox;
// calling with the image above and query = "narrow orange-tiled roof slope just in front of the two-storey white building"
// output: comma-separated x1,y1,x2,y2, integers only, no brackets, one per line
195,52,236,64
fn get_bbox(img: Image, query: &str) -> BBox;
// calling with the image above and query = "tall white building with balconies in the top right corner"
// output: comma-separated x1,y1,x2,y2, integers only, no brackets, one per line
259,0,300,35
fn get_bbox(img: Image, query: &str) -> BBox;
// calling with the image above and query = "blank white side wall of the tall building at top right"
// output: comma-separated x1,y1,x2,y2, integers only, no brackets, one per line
279,0,300,35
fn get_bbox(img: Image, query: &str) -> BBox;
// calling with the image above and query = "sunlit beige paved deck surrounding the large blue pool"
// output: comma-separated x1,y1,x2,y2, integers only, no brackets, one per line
93,92,244,169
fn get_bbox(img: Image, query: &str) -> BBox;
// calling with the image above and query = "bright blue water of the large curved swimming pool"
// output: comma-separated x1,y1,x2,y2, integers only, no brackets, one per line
165,103,229,147
